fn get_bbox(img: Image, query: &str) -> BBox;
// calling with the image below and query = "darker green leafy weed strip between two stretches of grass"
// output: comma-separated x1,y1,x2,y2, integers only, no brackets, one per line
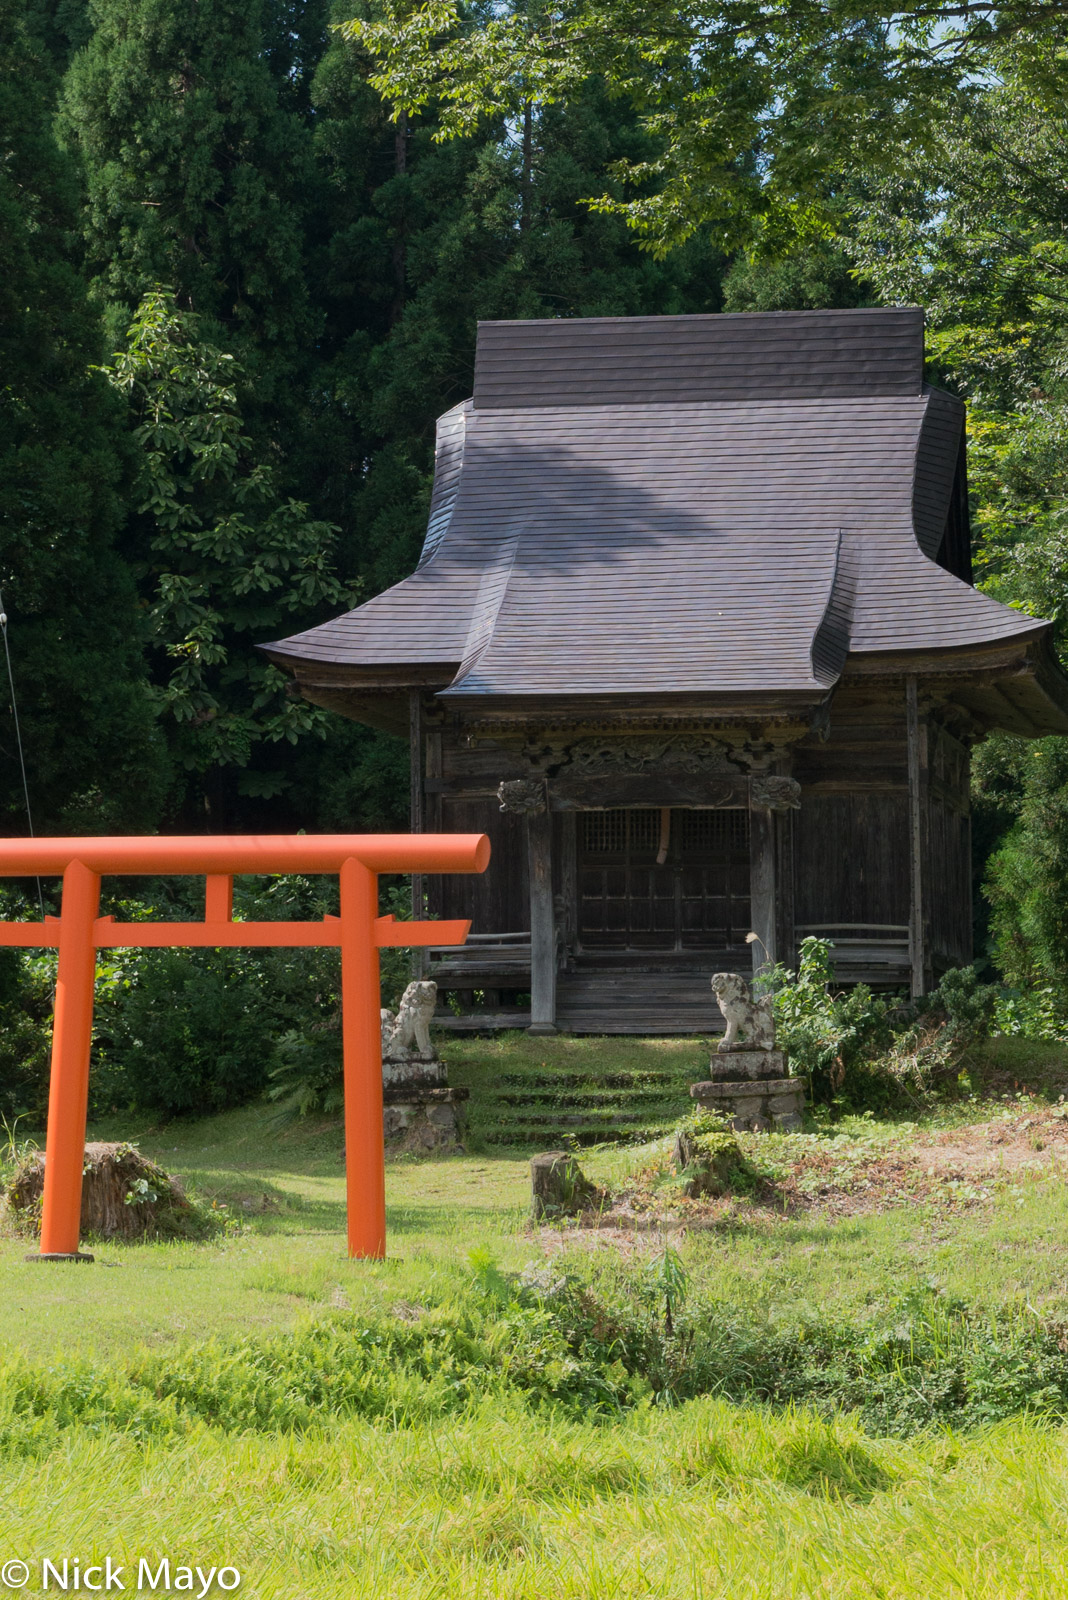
0,1251,1068,1459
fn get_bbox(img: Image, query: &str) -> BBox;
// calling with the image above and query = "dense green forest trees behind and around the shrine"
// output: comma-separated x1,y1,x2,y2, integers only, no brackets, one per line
0,0,1068,1109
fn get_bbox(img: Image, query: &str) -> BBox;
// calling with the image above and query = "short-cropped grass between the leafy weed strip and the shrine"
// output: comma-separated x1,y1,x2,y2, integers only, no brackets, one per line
0,1068,1068,1355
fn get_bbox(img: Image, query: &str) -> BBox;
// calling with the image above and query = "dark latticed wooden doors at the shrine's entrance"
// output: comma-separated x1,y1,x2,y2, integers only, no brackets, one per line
577,806,751,958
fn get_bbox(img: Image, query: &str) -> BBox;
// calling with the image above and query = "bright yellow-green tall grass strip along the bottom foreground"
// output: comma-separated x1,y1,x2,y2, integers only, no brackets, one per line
3,1402,1068,1600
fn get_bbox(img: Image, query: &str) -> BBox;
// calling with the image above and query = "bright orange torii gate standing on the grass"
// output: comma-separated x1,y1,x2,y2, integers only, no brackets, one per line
0,834,489,1261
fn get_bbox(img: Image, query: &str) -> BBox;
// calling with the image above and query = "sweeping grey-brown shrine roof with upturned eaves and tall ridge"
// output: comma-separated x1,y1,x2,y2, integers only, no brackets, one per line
265,309,1049,702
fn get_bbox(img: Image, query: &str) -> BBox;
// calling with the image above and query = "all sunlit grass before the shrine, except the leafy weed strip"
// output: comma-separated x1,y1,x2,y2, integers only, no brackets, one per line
0,1040,1068,1600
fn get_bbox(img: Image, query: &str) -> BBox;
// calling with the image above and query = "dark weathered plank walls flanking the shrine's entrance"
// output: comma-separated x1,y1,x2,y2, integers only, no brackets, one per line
425,685,972,976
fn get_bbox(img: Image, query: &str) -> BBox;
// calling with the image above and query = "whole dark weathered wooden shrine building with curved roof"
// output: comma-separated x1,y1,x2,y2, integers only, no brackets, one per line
269,309,1068,1032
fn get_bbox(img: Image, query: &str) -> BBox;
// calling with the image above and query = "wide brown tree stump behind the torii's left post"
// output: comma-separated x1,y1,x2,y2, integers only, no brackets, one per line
6,1144,203,1238
